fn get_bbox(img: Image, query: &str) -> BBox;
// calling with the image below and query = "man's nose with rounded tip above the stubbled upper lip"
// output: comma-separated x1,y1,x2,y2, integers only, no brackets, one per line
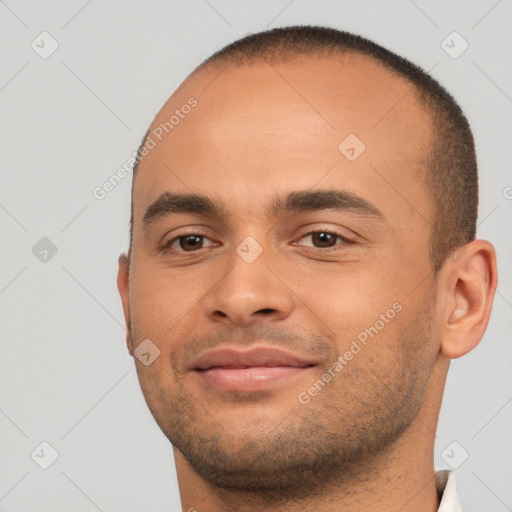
202,243,294,325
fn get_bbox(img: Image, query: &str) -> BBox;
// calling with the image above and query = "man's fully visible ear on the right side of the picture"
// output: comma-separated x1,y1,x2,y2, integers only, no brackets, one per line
441,240,498,359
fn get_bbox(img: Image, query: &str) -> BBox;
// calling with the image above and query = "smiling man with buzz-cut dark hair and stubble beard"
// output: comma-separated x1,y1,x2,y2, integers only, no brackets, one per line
118,27,497,512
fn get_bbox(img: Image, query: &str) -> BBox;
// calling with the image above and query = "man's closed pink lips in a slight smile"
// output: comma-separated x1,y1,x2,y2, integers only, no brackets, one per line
191,347,317,393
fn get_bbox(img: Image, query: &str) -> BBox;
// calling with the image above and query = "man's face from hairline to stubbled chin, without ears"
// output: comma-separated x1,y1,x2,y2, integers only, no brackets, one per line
120,56,439,491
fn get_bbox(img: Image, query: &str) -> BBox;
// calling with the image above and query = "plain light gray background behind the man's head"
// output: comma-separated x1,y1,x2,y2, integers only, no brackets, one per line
0,0,512,512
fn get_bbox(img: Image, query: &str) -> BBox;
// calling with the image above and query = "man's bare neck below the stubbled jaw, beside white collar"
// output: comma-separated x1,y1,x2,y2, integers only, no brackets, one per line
174,356,449,512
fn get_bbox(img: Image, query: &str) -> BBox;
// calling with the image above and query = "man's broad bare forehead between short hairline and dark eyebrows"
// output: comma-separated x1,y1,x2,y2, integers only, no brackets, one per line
134,55,432,226
